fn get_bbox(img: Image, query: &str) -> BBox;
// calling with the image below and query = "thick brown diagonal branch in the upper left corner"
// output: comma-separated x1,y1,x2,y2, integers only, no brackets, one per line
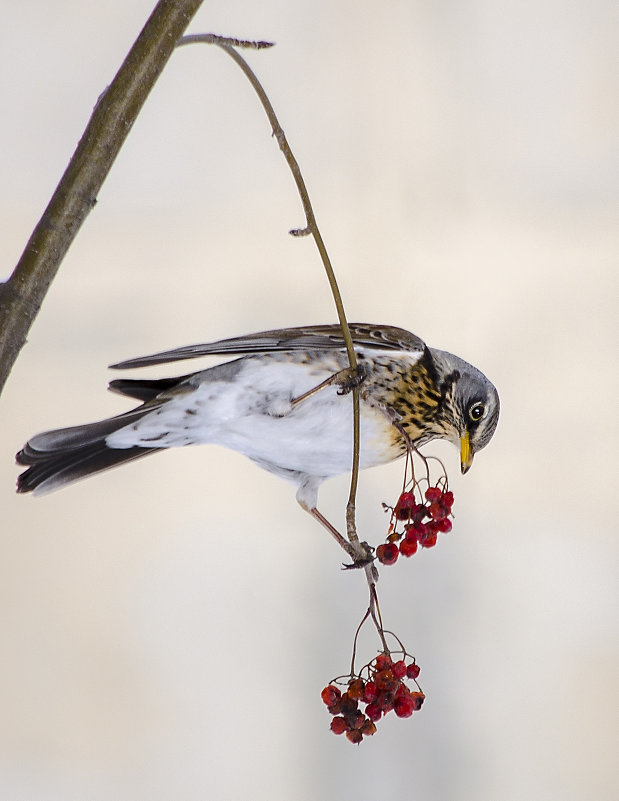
0,0,202,393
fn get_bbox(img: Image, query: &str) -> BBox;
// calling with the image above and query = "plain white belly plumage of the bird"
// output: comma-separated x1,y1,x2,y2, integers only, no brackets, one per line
107,354,393,477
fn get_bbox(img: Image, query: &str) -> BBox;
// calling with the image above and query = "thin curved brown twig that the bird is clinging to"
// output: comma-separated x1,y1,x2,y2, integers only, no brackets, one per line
177,33,360,542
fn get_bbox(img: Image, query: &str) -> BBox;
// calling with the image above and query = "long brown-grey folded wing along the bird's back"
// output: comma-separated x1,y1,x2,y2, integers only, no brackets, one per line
110,323,425,370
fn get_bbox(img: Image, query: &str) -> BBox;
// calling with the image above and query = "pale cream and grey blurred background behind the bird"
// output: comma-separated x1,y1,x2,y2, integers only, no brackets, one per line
0,0,619,801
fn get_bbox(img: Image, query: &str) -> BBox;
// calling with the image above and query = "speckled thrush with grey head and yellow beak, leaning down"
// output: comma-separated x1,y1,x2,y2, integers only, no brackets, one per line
16,323,500,526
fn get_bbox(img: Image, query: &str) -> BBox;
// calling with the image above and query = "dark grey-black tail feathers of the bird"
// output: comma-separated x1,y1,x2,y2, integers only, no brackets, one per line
15,404,160,495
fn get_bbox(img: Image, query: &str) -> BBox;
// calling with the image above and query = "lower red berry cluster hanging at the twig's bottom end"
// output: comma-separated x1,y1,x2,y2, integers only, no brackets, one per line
321,653,425,743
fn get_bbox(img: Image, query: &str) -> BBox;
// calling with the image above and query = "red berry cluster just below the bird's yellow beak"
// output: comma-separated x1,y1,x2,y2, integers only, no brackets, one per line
376,486,454,565
